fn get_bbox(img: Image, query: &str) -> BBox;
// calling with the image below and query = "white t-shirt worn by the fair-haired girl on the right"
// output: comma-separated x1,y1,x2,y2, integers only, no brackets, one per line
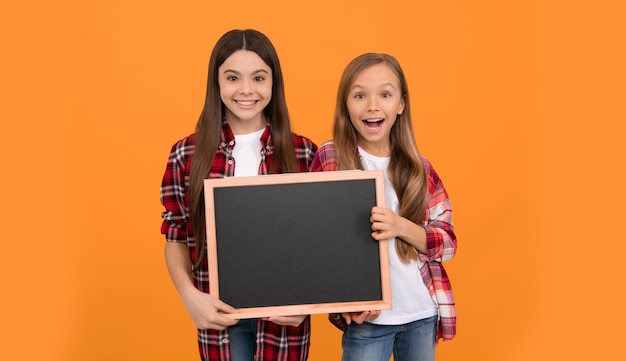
359,147,437,325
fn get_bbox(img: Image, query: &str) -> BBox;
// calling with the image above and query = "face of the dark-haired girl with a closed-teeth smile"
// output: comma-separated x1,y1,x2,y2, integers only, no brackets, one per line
218,50,272,134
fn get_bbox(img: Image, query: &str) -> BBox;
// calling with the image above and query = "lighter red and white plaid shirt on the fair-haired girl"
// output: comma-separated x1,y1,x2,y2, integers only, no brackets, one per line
311,141,457,340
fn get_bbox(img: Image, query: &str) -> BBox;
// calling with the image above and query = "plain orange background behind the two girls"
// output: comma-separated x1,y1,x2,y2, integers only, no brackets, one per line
0,0,626,361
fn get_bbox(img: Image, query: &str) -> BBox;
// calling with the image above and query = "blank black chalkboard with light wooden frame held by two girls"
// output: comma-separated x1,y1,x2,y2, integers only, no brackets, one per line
204,171,391,318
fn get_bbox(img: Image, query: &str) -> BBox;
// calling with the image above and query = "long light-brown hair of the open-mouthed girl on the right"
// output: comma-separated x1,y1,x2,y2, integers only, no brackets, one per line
333,53,428,263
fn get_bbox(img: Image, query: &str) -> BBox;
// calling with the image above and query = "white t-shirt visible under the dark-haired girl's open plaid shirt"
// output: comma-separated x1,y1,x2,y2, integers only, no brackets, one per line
233,128,265,177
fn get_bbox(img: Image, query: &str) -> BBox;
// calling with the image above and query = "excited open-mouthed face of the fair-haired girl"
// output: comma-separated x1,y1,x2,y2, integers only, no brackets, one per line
346,63,404,157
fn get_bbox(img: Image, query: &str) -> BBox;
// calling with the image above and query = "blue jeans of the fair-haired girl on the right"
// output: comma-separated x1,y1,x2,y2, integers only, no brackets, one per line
341,316,437,361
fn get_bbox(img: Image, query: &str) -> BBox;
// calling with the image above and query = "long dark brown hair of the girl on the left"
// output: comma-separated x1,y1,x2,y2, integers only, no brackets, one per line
189,29,298,270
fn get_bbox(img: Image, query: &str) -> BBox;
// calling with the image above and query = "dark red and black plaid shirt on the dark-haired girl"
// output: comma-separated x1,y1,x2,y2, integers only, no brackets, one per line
161,123,317,361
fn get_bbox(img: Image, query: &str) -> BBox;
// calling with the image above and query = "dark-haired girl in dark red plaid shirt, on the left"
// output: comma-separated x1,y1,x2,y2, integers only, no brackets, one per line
161,30,317,361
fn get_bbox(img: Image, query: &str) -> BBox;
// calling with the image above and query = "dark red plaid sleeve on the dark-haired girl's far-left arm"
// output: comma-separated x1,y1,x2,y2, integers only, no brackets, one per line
160,137,193,243
